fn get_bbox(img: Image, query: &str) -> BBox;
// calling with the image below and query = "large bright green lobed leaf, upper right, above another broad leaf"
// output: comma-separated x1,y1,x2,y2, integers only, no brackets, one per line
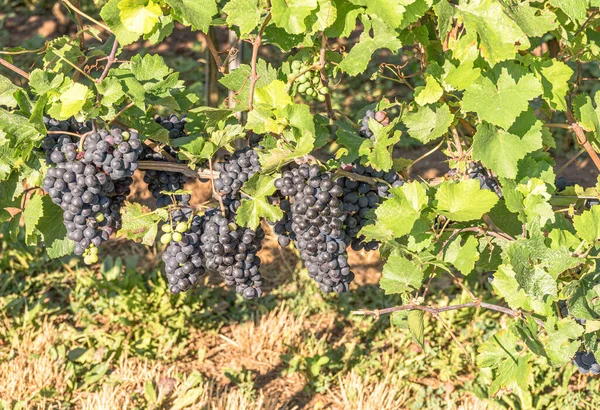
462,66,543,130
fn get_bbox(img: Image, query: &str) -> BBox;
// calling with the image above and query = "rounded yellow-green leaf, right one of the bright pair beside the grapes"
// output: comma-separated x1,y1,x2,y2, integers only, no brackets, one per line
435,179,498,222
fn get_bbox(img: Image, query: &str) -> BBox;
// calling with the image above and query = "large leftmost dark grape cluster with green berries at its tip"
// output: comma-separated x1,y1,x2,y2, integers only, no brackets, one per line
42,119,141,264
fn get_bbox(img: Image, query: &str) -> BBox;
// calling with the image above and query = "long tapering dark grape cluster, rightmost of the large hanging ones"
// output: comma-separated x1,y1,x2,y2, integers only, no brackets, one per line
275,164,354,293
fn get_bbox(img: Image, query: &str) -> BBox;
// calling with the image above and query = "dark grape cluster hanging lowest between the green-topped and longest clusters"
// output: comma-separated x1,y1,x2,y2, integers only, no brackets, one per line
200,209,265,299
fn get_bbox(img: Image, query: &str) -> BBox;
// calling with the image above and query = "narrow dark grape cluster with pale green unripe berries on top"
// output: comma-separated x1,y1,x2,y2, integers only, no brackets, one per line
161,208,205,295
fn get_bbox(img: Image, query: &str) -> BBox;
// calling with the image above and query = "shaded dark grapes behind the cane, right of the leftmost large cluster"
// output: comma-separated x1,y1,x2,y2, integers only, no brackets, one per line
141,114,191,208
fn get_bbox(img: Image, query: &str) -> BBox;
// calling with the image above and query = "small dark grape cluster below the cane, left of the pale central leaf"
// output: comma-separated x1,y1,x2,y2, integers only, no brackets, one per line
214,148,260,212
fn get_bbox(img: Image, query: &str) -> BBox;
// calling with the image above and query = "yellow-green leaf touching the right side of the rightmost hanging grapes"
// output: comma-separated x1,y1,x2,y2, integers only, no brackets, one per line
361,182,428,241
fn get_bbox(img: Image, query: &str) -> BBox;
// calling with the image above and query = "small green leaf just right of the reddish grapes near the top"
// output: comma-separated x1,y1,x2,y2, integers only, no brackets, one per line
402,104,454,144
